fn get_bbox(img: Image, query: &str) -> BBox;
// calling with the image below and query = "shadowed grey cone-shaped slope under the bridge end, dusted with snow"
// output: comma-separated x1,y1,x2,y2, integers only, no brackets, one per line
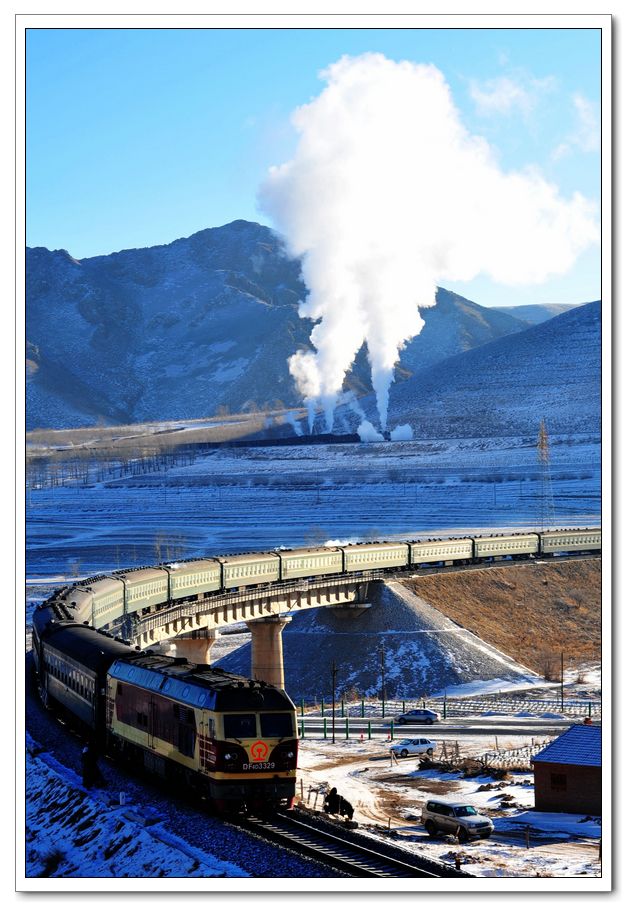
215,585,539,699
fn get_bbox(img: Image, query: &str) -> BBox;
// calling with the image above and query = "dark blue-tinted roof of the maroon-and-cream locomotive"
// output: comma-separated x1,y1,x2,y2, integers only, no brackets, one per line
109,653,294,712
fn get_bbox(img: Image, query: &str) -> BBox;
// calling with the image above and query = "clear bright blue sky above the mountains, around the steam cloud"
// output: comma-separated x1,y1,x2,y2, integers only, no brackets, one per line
26,29,600,305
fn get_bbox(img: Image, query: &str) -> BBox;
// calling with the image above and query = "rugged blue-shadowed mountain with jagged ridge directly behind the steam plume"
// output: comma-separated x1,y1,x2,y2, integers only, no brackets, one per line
26,220,527,428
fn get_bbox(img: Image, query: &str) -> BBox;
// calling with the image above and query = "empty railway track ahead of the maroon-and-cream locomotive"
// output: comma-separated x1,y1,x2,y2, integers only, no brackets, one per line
240,814,472,879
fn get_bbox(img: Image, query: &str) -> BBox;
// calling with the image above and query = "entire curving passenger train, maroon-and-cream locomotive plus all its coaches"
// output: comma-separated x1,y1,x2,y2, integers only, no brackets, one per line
33,528,601,812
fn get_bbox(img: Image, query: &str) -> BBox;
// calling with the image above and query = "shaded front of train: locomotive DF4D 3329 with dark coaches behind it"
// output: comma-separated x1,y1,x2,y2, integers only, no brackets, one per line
33,602,298,813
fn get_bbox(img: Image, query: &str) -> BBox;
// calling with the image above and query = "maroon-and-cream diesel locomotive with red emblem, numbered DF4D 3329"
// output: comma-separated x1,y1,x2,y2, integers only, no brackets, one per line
107,656,298,807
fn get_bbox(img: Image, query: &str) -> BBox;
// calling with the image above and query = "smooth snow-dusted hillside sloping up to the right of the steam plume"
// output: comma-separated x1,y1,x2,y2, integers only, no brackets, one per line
380,301,601,437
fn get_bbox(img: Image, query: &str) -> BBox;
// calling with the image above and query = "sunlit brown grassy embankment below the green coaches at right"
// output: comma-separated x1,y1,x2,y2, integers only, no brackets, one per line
407,559,601,679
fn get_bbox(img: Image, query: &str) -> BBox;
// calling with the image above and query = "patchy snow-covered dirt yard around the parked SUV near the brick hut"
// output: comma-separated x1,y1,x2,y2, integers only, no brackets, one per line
299,733,601,878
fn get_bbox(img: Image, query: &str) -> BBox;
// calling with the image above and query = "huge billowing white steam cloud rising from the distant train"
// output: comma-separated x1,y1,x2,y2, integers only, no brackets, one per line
260,54,598,430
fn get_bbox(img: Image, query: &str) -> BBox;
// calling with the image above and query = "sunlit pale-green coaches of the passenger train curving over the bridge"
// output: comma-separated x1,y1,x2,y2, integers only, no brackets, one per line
51,528,601,632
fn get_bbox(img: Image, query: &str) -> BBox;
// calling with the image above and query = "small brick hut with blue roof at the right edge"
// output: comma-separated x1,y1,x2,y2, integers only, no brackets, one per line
532,725,601,815
